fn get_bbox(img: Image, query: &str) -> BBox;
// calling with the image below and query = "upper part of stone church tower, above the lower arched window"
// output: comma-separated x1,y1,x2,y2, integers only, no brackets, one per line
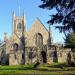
12,12,26,43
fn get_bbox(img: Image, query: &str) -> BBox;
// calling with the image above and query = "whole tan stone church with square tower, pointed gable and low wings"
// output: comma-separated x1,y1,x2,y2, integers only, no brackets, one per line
0,12,71,65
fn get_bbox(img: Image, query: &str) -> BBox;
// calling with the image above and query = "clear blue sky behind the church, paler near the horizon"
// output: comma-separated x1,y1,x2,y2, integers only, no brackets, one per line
0,0,64,43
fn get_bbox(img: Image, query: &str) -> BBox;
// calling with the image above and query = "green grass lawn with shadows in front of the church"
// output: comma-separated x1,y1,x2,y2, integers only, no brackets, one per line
0,63,75,75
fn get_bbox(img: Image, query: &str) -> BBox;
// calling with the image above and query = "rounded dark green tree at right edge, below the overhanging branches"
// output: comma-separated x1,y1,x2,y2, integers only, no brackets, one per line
65,33,75,49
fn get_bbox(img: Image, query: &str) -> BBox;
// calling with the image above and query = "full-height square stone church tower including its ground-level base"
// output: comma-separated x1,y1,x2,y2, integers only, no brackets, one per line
9,12,25,65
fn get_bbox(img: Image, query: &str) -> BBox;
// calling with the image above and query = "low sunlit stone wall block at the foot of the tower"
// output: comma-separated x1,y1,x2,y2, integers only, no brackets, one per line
9,50,23,65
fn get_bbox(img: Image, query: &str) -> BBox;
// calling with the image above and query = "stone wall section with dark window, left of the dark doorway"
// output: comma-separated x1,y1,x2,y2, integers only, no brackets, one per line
25,47,37,64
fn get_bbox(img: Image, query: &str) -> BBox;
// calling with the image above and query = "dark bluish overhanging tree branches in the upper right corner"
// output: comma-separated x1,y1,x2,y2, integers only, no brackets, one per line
39,0,75,35
